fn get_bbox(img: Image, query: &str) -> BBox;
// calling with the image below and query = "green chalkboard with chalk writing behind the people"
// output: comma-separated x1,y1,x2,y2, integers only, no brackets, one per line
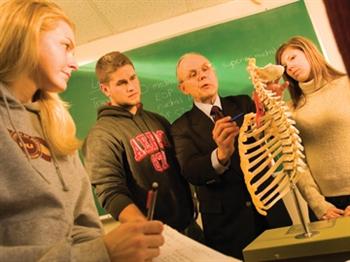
62,1,317,215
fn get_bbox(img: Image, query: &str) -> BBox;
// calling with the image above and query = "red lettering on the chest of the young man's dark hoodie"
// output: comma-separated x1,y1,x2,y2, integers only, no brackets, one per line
130,130,169,172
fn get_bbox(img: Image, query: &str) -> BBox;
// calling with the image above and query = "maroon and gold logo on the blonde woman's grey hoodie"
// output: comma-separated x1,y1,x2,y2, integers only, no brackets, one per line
8,129,51,162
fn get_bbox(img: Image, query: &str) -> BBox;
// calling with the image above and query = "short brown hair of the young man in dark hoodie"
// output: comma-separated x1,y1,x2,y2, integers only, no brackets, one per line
95,51,134,83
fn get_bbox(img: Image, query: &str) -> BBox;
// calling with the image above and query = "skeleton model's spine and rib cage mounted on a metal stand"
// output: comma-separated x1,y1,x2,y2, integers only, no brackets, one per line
238,59,306,215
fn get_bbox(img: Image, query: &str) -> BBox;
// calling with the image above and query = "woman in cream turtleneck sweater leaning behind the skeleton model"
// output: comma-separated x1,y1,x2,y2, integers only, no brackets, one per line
276,36,350,219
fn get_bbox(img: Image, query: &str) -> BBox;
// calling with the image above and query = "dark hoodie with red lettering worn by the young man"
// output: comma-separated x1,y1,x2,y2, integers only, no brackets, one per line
83,106,193,230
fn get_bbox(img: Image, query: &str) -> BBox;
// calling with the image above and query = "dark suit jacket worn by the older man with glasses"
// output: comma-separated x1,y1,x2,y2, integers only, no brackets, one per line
171,95,291,258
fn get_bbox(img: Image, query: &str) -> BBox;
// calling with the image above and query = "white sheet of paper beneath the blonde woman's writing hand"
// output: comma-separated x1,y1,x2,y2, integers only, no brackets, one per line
153,225,241,262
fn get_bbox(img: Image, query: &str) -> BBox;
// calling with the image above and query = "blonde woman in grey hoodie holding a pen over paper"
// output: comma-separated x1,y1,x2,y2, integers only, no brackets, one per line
0,0,164,261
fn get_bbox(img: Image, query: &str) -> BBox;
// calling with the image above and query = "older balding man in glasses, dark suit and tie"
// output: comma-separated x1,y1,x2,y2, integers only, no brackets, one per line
171,53,291,258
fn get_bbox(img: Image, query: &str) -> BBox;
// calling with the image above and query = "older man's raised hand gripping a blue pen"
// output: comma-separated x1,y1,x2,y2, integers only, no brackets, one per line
212,116,239,165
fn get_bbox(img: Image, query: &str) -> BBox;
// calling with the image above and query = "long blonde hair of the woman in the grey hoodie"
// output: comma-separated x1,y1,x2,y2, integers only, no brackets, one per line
0,0,80,156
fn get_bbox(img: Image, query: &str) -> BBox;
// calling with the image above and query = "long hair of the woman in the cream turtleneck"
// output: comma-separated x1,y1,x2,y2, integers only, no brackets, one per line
275,36,346,107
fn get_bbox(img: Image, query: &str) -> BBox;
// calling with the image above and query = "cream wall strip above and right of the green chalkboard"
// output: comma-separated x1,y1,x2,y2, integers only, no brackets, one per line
76,0,345,71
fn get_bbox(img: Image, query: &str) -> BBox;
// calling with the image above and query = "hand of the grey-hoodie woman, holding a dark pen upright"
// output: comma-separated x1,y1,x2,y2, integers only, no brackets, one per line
103,221,164,262
